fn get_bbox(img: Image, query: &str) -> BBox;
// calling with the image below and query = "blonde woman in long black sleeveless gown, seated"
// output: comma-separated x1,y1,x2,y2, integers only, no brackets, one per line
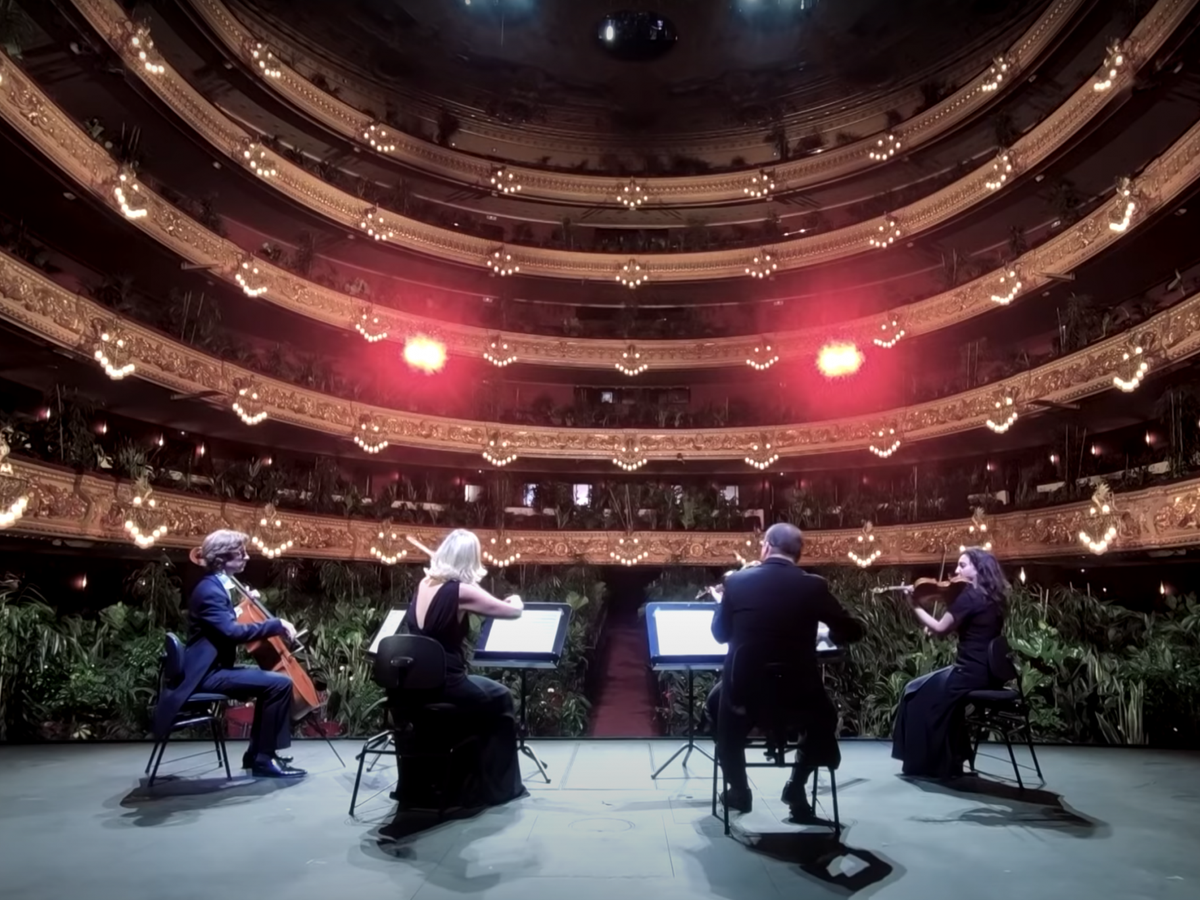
401,528,524,808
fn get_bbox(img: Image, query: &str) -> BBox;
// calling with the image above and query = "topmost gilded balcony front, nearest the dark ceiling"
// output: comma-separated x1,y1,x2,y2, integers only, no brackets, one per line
182,0,1085,205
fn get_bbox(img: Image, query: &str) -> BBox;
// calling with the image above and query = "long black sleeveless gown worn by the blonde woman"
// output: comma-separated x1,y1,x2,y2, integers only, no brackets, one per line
401,581,524,808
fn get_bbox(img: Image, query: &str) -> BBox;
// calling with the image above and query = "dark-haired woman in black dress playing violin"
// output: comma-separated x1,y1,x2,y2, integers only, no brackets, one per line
892,547,1008,779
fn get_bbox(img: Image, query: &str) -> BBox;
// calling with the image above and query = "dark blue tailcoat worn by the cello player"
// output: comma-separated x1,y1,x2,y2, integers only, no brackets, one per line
154,575,287,740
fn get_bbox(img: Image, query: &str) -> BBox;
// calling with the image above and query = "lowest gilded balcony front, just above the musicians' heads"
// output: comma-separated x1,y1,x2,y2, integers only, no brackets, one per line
10,460,1200,566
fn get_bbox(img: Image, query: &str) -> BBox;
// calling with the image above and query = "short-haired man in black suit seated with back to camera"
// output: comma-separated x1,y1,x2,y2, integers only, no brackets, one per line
706,523,863,821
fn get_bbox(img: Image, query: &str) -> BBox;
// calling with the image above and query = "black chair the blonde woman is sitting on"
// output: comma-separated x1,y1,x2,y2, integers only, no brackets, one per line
350,635,479,816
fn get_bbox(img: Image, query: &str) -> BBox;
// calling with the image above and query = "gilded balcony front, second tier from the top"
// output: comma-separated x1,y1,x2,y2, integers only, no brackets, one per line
60,0,1196,282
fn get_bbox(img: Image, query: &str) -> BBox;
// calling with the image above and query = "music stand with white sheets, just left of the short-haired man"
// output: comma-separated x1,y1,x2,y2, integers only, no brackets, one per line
646,601,728,779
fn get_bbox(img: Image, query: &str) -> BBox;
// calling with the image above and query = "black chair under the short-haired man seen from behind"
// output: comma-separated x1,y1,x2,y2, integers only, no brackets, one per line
713,644,841,836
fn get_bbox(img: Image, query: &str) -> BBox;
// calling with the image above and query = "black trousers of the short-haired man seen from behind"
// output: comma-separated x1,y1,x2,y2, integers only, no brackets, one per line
704,682,841,791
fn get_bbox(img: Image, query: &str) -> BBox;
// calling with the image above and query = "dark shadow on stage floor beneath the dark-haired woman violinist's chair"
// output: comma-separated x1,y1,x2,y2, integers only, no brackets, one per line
900,775,1111,838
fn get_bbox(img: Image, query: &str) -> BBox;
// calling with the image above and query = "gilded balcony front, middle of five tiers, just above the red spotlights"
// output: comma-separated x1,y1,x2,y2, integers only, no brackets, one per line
0,56,1200,370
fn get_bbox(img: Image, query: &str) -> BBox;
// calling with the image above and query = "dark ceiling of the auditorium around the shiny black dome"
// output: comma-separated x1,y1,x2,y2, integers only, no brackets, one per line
232,0,1045,132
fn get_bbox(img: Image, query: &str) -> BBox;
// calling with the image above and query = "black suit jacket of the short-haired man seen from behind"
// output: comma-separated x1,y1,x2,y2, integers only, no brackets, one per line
713,557,864,683
